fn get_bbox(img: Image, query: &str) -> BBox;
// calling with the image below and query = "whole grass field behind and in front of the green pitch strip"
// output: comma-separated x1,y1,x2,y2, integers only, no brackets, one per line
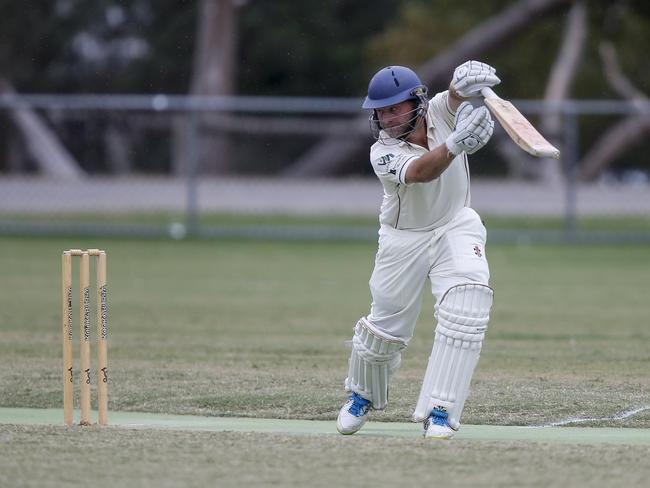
0,234,650,486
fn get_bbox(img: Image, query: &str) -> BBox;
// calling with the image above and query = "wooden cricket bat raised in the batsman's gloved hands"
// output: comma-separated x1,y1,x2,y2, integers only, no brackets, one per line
481,87,560,159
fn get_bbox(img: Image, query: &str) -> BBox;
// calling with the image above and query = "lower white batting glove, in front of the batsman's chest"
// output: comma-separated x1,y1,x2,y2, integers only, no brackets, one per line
445,102,494,156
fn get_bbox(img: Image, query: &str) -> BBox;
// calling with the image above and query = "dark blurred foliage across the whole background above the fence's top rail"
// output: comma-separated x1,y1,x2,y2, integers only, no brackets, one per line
0,0,650,178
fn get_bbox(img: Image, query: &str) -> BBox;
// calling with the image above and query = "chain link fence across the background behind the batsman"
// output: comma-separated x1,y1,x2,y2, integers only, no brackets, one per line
0,94,650,241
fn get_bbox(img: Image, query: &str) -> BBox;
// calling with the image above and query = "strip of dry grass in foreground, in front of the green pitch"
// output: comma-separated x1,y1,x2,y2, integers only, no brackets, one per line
0,426,650,488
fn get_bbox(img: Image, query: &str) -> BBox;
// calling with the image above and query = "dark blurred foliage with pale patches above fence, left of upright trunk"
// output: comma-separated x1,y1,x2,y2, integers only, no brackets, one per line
0,0,196,93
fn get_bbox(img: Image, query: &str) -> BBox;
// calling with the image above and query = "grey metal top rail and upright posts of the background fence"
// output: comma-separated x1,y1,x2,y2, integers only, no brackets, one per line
0,93,650,239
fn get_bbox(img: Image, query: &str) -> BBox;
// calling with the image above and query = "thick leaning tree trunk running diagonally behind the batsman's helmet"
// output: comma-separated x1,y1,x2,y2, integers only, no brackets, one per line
283,0,573,176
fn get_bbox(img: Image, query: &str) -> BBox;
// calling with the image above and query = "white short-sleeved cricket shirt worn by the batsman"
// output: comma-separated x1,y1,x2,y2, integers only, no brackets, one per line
370,91,470,231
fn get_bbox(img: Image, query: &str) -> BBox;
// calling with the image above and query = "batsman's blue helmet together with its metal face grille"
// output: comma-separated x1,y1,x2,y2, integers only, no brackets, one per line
362,66,428,142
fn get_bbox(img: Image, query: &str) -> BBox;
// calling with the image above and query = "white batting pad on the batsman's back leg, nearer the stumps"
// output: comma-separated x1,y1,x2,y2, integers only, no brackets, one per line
345,317,406,410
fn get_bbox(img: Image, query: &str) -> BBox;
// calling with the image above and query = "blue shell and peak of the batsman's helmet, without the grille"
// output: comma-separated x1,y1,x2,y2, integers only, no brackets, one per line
362,66,427,109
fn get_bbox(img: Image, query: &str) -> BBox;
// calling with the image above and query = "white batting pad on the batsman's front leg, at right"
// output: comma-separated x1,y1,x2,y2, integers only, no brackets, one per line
413,283,493,429
